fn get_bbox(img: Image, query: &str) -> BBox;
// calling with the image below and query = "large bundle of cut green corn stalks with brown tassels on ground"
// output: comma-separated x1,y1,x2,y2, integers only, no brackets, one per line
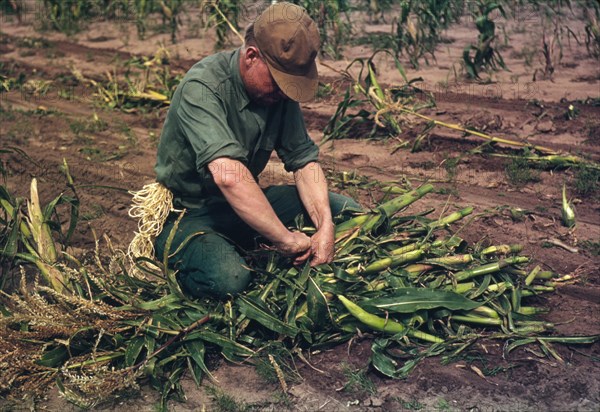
0,178,600,407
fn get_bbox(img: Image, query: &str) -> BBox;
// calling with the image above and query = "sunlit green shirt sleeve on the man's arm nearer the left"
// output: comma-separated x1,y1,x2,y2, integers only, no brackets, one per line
177,81,247,173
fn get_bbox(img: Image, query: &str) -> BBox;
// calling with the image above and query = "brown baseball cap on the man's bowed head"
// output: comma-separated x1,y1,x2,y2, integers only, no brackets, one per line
254,2,320,102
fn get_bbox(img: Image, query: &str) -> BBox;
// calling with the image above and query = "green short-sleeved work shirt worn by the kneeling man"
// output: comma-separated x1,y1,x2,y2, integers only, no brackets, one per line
154,49,319,208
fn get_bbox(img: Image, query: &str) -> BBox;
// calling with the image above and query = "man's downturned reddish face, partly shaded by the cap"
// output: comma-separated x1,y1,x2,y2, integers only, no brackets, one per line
244,50,288,106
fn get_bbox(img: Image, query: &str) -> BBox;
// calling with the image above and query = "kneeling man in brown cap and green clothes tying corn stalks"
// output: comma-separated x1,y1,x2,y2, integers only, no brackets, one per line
155,3,358,297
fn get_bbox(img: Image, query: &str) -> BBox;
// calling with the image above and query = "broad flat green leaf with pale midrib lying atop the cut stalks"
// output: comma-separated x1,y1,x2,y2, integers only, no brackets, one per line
361,288,482,313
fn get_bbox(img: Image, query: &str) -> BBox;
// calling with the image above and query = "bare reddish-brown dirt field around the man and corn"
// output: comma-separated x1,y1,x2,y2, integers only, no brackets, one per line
0,3,600,411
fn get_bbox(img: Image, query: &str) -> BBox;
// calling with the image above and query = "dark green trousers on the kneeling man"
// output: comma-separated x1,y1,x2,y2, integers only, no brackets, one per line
155,186,360,298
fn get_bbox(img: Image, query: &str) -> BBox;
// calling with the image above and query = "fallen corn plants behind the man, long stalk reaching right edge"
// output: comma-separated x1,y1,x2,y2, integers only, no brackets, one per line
321,51,600,174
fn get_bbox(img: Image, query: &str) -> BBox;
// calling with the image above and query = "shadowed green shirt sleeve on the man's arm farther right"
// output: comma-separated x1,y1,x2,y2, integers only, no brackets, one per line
275,100,319,172
